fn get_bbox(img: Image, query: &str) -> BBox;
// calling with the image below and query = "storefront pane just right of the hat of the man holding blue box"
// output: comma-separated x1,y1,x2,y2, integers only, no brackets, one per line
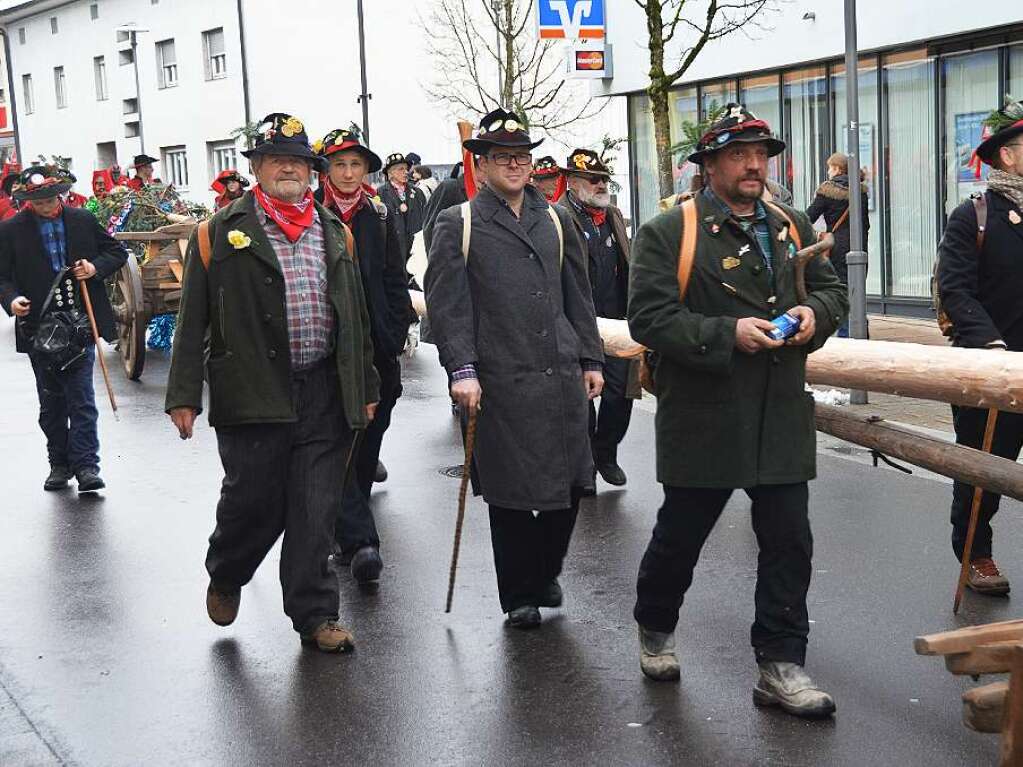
783,66,829,209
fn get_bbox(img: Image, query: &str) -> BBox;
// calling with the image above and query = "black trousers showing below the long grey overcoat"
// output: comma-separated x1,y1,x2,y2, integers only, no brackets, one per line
490,491,579,613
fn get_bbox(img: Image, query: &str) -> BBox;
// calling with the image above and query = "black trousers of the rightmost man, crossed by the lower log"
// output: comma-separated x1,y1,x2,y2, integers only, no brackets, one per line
951,405,1023,561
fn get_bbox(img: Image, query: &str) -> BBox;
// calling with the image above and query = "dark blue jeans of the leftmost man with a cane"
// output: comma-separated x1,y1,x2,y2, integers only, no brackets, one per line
29,346,99,472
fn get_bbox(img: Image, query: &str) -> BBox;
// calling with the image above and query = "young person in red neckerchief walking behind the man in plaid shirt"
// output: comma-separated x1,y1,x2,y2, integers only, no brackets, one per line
316,125,412,583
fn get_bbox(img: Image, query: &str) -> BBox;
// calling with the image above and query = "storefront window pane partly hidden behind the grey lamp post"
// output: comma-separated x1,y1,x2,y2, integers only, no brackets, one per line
825,61,884,296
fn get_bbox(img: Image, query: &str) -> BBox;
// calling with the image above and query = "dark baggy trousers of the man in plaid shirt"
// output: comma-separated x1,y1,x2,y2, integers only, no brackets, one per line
206,361,352,633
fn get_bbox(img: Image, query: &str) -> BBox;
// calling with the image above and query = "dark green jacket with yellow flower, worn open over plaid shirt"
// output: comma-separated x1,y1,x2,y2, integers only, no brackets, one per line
166,191,380,428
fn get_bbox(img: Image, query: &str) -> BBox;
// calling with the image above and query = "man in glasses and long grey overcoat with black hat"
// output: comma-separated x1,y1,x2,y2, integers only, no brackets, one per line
426,109,604,628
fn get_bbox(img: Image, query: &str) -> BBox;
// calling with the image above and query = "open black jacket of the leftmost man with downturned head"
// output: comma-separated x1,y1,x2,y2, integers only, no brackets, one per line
0,206,128,353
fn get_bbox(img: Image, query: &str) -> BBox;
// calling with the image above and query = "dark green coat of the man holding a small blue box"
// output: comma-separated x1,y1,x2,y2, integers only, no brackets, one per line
628,193,849,488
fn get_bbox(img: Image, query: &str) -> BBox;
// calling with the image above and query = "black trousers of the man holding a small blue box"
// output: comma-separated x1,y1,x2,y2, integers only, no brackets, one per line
633,482,813,665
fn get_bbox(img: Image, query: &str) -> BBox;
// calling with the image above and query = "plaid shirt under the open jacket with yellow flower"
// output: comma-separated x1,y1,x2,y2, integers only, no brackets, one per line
256,206,336,370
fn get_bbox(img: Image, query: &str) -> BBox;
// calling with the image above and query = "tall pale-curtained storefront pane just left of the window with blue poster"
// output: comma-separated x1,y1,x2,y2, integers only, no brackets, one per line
884,52,937,298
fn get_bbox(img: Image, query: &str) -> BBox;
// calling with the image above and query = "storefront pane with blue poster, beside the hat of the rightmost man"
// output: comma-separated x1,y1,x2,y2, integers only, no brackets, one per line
941,50,999,215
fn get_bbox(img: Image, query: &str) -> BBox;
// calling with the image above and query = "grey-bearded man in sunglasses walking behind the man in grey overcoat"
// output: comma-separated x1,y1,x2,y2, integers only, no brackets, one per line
561,149,638,487
